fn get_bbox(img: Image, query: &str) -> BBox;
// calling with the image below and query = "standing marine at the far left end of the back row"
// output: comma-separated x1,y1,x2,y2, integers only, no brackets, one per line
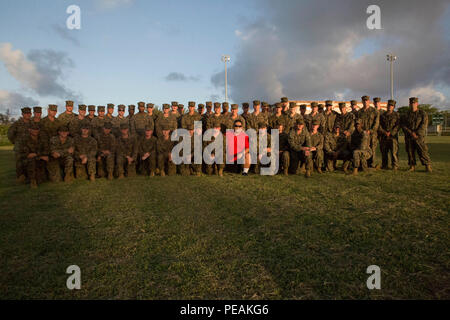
7,107,32,179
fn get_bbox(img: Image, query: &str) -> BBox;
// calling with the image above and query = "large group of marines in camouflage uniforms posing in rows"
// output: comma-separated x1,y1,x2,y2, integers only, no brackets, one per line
8,96,432,188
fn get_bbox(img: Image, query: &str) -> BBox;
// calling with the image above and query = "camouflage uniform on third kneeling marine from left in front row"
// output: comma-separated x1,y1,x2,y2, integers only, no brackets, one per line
74,135,97,178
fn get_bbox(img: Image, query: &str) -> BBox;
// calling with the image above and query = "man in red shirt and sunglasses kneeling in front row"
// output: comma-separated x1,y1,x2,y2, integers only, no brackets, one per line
226,120,250,176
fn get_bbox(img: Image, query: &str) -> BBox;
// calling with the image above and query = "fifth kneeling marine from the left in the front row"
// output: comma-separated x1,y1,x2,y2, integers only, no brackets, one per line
116,124,138,179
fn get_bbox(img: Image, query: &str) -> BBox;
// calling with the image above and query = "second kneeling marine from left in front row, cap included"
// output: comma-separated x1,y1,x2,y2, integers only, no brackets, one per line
47,126,75,182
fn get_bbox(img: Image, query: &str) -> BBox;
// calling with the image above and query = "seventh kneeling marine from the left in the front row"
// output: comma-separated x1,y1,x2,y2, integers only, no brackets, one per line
156,124,177,177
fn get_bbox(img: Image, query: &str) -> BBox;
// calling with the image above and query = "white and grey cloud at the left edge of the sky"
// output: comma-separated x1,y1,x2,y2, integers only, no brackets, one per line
0,43,80,100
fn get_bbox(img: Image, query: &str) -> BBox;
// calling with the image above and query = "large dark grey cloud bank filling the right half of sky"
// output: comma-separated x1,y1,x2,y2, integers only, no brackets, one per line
211,0,450,109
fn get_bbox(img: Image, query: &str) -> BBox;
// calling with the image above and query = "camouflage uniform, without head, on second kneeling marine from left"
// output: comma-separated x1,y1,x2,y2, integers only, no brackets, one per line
47,136,74,182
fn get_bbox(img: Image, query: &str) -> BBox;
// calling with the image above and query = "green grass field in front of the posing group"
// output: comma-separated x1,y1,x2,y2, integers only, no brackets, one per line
0,137,450,299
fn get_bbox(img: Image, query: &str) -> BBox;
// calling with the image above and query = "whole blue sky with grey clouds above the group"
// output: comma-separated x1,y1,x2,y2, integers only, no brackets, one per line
0,0,450,115
